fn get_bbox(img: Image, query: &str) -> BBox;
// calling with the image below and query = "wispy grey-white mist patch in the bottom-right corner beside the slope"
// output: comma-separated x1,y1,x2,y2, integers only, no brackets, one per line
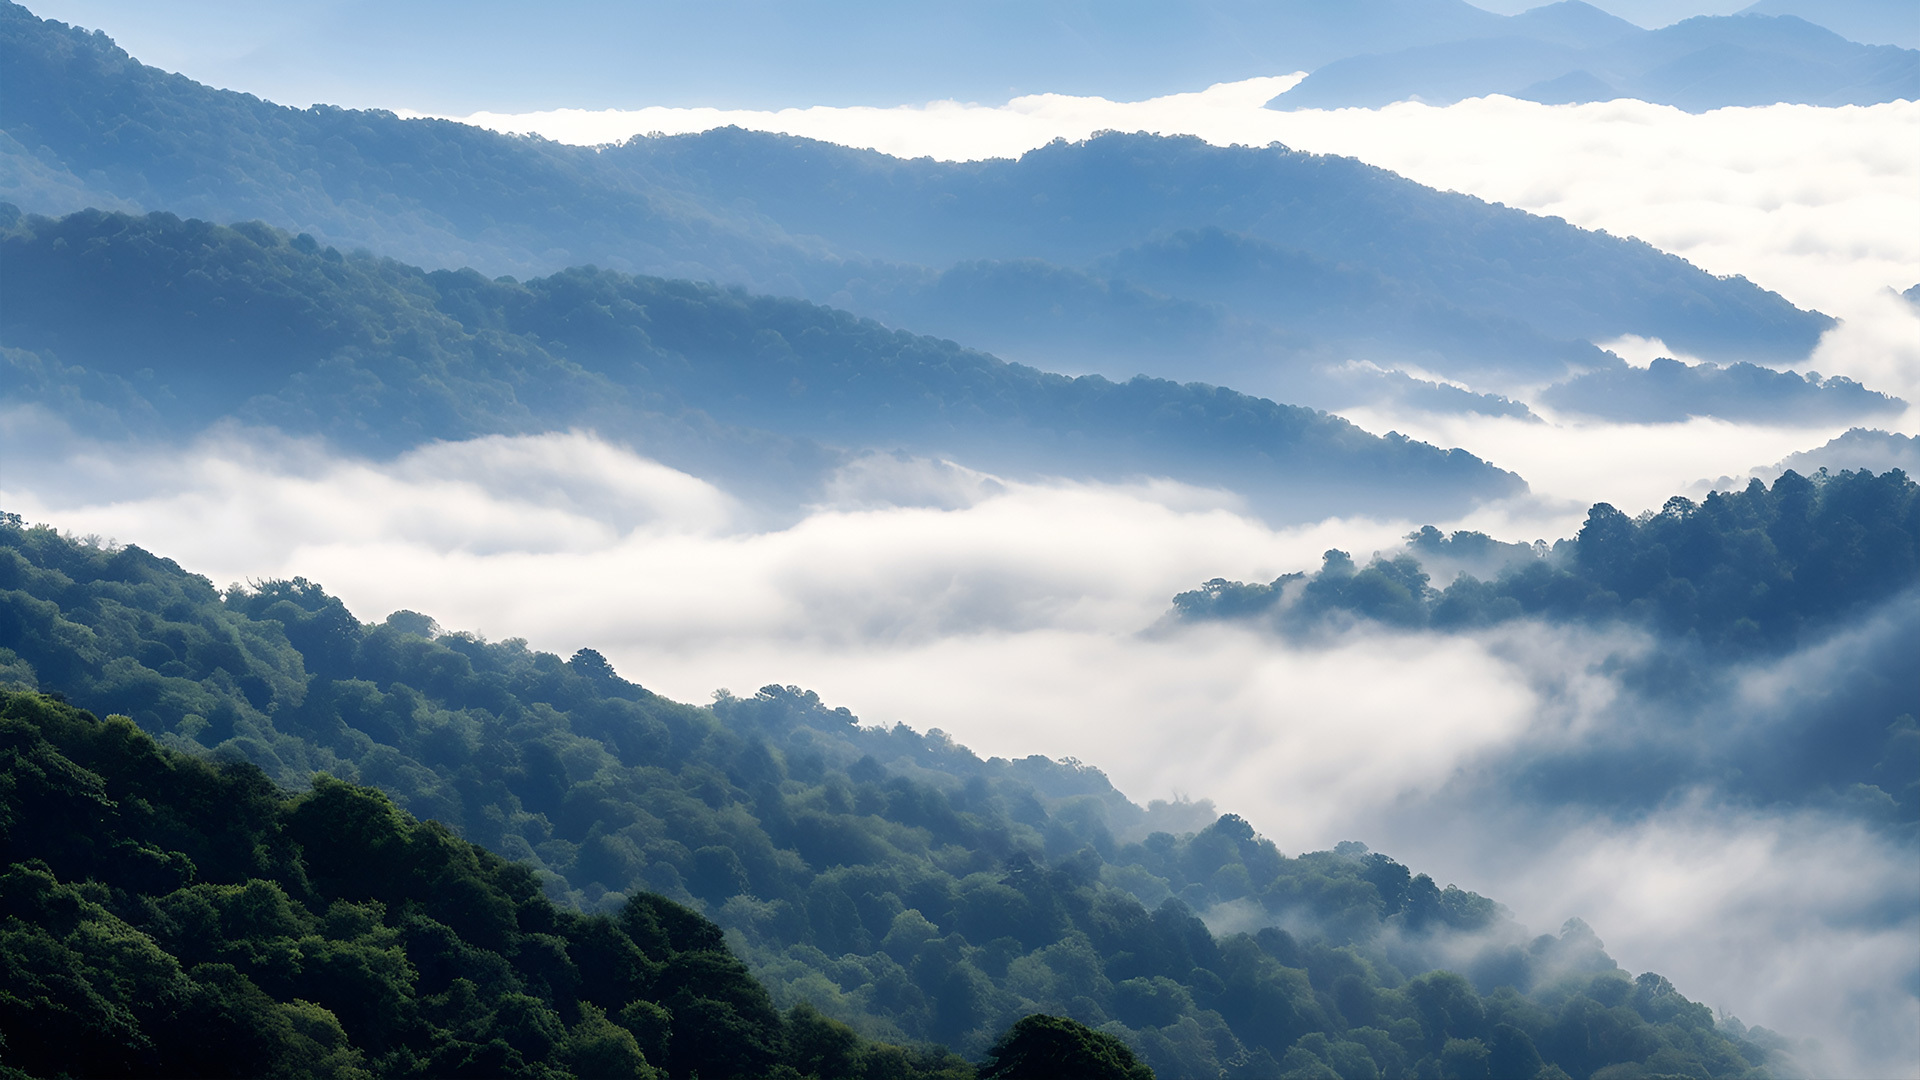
1413,799,1920,1076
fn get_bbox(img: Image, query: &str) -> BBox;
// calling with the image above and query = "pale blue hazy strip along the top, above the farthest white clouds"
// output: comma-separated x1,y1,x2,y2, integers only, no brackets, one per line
29,0,1920,115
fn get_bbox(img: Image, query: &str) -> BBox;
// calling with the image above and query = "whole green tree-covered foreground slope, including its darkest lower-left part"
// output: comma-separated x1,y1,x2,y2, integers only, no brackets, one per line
0,515,1795,1080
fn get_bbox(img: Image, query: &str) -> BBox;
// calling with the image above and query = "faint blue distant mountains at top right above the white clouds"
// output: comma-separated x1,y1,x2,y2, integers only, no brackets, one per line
1271,0,1920,111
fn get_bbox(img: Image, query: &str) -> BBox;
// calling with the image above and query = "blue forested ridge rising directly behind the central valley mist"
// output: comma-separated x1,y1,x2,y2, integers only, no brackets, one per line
0,206,1524,517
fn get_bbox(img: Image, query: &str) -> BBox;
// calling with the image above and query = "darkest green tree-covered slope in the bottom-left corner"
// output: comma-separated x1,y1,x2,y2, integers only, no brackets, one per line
0,690,973,1080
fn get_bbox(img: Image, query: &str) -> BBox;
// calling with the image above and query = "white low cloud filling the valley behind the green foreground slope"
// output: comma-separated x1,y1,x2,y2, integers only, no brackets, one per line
0,413,1914,1065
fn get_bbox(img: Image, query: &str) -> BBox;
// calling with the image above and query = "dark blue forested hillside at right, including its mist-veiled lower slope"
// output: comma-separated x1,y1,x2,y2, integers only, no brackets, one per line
1173,466,1920,826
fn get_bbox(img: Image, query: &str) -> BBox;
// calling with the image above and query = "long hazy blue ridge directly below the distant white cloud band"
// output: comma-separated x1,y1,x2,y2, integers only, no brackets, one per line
0,4,1832,402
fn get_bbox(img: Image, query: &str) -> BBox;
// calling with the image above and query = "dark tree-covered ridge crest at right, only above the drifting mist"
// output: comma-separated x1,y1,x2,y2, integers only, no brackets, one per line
1173,469,1920,651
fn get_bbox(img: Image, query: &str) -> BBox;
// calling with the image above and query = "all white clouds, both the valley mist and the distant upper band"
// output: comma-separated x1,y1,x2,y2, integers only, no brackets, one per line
0,79,1920,1076
